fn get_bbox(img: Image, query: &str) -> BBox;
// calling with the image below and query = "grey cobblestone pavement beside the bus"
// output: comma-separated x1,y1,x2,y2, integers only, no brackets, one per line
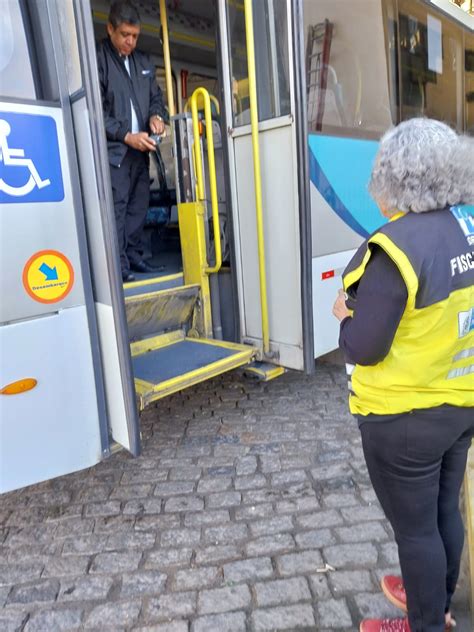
0,364,469,632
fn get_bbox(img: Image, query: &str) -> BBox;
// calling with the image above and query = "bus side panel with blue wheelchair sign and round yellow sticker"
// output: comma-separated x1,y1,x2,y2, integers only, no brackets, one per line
0,102,102,492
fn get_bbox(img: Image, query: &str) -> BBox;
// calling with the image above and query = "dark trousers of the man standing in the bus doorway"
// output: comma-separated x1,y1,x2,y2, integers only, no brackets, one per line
110,149,150,271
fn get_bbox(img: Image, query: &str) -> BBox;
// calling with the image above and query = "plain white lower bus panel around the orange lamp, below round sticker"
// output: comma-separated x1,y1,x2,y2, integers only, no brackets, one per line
0,306,102,493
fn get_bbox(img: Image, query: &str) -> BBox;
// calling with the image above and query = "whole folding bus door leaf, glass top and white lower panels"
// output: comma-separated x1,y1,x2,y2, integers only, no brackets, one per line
219,0,312,369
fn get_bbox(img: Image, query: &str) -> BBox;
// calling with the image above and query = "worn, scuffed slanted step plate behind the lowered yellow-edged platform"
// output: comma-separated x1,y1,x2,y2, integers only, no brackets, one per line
125,285,199,342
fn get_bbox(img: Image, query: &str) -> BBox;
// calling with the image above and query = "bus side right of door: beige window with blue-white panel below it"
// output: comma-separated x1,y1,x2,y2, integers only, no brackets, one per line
302,0,395,357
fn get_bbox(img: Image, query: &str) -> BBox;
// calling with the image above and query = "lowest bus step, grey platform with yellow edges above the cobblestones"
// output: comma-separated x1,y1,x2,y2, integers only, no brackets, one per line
131,331,257,410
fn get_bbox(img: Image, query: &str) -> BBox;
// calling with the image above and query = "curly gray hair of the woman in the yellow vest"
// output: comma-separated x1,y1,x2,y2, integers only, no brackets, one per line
369,118,474,213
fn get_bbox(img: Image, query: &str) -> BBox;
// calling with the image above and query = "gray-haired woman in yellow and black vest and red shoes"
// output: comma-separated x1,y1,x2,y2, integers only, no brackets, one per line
333,119,474,632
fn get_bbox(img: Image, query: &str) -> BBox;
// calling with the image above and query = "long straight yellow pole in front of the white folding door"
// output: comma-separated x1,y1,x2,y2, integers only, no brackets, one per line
244,0,270,353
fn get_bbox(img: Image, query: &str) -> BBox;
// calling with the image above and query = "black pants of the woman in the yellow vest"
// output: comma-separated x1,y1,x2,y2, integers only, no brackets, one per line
359,406,474,632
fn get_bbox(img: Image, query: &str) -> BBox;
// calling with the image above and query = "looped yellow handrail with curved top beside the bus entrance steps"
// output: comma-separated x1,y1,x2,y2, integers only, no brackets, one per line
191,88,222,274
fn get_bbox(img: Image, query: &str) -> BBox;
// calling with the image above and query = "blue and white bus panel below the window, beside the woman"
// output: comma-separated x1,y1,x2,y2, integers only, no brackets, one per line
308,134,385,357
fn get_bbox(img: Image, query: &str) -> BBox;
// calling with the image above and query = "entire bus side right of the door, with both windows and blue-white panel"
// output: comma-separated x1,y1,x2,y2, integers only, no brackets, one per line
303,0,474,356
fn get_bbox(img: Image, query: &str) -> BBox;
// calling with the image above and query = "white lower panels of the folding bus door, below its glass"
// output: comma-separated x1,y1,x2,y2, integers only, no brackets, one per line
234,126,302,346
